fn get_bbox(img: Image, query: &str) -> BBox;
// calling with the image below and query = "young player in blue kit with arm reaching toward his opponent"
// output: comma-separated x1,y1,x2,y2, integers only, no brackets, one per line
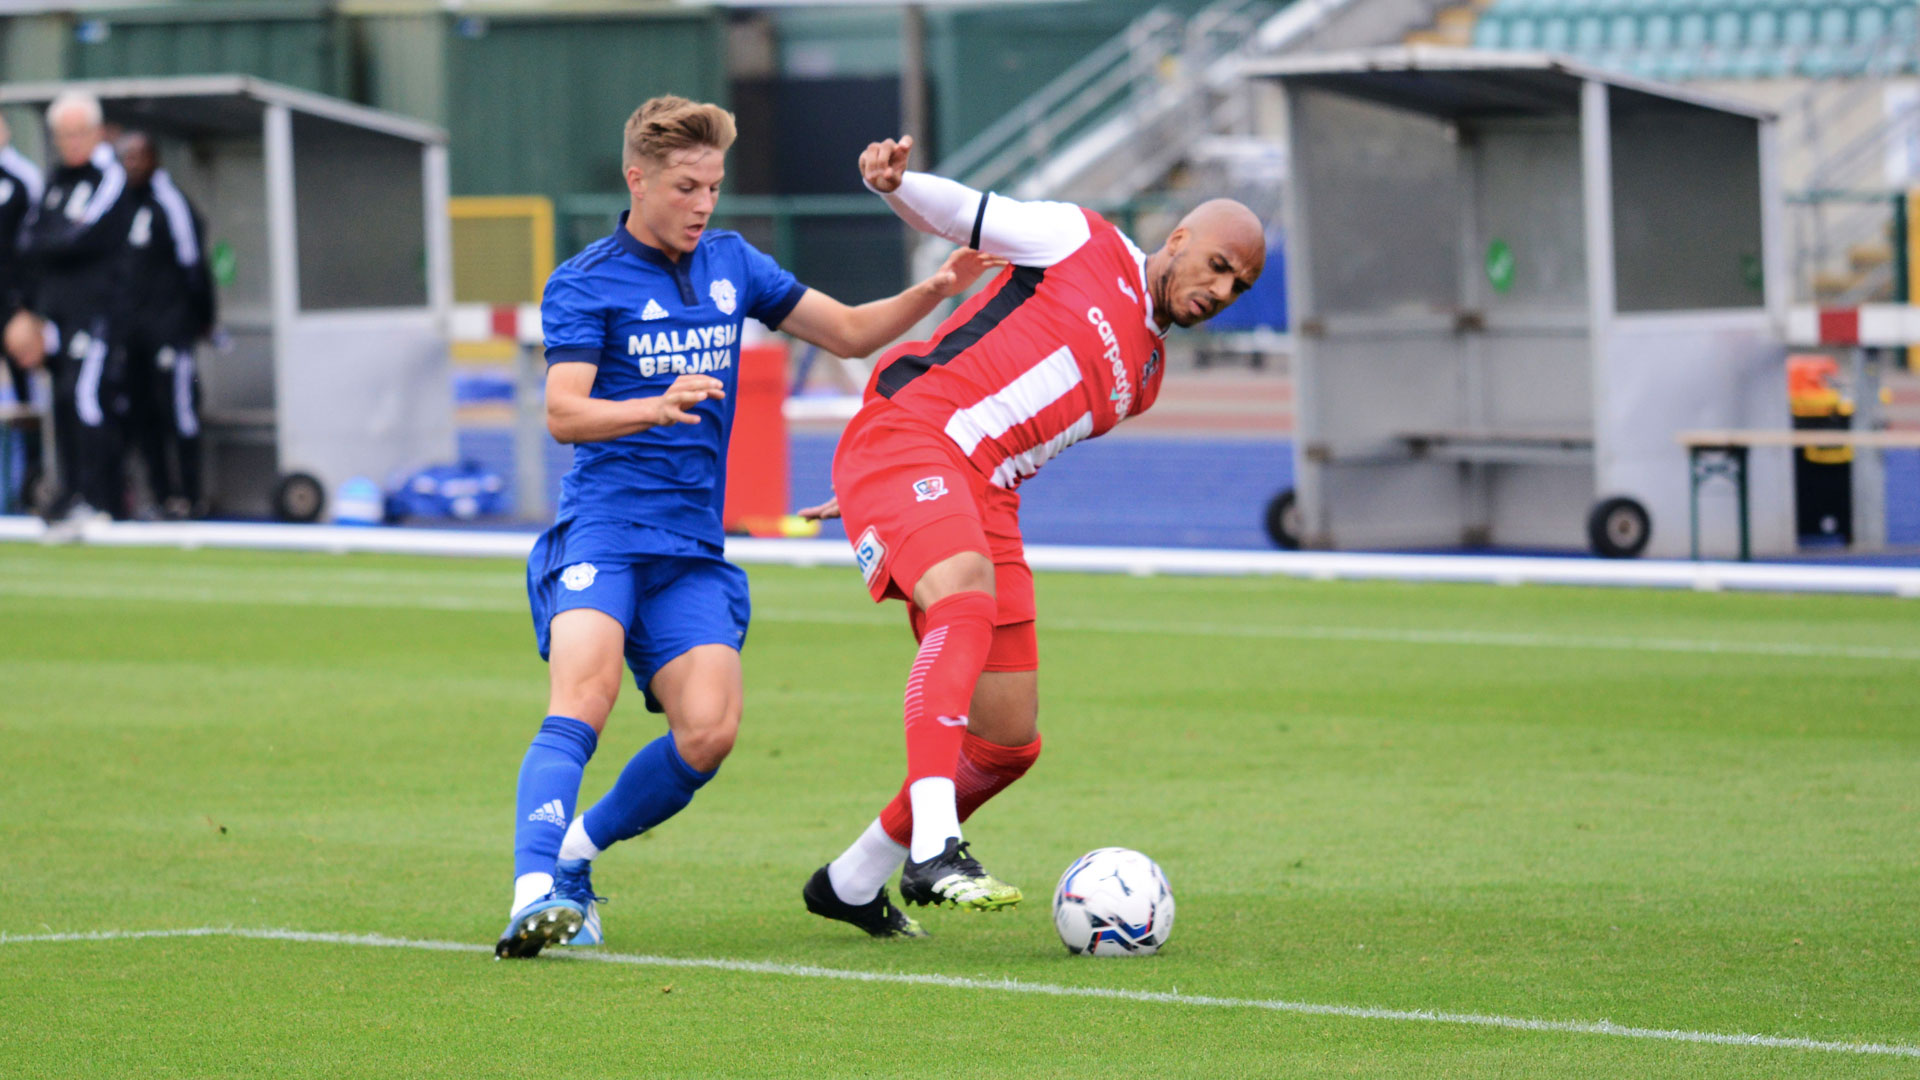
493,96,1002,957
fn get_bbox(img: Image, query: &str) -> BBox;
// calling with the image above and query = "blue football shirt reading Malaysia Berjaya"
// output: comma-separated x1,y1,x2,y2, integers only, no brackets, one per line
540,213,806,546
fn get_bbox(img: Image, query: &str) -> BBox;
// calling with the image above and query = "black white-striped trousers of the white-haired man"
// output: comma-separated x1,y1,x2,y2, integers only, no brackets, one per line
46,317,127,517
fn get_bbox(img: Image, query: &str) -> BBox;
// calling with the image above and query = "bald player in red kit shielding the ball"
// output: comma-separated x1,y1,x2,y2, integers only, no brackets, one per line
803,136,1265,938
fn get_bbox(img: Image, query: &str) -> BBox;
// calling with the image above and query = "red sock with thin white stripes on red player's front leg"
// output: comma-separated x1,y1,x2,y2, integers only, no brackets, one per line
906,592,995,784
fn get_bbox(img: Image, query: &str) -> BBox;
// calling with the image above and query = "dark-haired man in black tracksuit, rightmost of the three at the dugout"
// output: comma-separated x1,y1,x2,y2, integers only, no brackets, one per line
119,133,213,519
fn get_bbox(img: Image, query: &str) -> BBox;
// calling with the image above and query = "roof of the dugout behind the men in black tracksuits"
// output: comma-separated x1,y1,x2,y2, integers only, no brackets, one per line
0,75,447,146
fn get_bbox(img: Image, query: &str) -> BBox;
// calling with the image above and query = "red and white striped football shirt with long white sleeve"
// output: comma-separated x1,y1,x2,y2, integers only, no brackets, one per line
866,173,1165,488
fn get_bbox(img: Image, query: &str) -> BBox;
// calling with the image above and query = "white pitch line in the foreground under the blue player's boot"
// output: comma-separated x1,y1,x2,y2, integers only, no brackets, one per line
0,926,1920,1059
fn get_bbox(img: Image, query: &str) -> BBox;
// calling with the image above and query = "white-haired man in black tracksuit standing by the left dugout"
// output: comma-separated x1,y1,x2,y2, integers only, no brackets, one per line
21,92,134,521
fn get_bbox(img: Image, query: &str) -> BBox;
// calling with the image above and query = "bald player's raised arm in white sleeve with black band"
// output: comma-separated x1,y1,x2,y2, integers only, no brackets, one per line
860,135,1091,267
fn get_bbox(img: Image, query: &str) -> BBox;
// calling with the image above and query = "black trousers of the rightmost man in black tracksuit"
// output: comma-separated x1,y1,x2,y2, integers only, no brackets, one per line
127,331,200,507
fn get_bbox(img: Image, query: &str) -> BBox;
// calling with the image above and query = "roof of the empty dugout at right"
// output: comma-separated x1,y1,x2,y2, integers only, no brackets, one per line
1240,46,1776,121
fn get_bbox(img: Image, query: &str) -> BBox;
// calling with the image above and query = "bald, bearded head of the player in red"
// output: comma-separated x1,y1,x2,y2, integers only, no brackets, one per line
1146,198,1267,327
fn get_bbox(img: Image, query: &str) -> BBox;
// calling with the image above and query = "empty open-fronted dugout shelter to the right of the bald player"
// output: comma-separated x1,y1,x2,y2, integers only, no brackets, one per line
1244,48,1795,557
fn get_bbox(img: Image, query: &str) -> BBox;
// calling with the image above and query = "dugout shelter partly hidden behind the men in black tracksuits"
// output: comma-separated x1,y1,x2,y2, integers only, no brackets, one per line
0,75,455,521
